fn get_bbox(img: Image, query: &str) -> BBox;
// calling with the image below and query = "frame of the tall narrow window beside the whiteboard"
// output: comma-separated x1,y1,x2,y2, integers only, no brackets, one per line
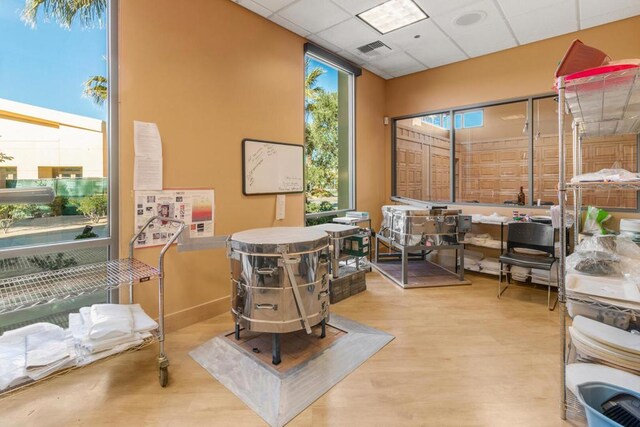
303,50,362,220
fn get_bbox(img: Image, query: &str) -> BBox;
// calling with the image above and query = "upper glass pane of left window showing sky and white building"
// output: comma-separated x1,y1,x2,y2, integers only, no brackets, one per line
0,0,108,248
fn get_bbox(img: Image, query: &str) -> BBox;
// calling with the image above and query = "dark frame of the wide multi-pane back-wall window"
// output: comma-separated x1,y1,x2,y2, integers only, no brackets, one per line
391,92,640,213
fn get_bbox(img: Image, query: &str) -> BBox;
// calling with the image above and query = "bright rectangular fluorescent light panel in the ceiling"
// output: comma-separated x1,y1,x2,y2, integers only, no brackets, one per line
357,0,429,34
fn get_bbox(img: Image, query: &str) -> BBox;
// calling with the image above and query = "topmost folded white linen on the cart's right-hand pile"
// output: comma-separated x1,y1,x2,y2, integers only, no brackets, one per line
89,304,133,340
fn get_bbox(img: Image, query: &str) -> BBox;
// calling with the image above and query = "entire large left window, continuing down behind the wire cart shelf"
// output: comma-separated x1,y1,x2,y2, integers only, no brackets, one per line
0,0,117,329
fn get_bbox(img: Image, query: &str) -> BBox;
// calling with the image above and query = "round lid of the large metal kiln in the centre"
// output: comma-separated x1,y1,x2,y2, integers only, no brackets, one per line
229,227,329,254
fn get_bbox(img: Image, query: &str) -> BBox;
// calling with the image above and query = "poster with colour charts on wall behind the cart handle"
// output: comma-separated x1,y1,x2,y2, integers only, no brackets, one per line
135,189,215,248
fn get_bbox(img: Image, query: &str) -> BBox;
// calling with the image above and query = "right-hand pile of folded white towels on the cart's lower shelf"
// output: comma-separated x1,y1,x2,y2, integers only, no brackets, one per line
69,304,158,364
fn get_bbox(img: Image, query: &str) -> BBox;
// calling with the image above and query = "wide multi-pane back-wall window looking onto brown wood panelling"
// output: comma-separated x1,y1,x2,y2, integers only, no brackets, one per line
393,96,638,210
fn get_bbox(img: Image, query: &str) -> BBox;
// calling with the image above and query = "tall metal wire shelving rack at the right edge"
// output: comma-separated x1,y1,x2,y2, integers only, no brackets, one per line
556,68,640,419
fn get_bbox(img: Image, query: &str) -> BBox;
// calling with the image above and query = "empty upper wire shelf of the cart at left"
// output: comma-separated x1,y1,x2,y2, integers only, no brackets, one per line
0,258,159,313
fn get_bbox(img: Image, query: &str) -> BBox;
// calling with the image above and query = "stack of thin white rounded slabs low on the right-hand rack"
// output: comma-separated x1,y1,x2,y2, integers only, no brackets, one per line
569,316,640,375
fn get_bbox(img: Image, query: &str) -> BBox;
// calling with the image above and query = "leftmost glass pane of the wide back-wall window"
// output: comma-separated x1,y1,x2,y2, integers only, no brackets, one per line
395,113,451,202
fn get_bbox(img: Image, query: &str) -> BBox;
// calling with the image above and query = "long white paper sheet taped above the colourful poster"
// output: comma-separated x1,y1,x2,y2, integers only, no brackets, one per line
133,121,162,190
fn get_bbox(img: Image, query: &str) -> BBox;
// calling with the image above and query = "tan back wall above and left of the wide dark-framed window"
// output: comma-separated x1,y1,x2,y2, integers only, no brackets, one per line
385,17,640,217
